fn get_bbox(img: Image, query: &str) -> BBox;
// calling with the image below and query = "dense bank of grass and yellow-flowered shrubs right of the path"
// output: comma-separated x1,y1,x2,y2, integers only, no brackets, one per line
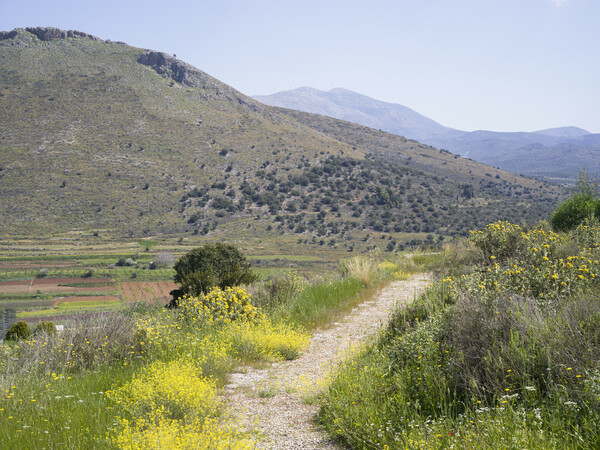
319,222,600,448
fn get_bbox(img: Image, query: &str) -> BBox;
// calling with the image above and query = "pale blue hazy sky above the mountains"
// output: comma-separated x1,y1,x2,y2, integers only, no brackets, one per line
0,0,600,133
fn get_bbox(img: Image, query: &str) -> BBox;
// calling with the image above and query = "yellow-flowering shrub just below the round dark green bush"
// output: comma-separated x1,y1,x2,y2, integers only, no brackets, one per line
138,288,310,364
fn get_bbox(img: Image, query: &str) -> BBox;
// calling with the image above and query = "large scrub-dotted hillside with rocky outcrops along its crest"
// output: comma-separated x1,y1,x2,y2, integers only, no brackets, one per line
0,28,564,246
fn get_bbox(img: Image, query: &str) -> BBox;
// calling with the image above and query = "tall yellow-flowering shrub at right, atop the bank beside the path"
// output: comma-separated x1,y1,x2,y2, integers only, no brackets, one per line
448,222,600,303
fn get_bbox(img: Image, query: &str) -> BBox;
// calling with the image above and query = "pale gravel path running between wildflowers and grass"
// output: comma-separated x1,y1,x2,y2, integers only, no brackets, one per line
224,275,431,450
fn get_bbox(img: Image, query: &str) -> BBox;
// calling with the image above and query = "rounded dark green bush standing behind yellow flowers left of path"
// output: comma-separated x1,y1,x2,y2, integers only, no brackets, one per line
174,243,257,295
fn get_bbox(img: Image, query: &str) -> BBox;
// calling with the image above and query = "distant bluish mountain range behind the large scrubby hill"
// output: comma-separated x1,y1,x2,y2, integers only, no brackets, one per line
254,87,600,181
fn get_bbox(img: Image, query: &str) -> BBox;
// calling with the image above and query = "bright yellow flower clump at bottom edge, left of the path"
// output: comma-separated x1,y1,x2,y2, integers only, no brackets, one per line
106,360,252,450
